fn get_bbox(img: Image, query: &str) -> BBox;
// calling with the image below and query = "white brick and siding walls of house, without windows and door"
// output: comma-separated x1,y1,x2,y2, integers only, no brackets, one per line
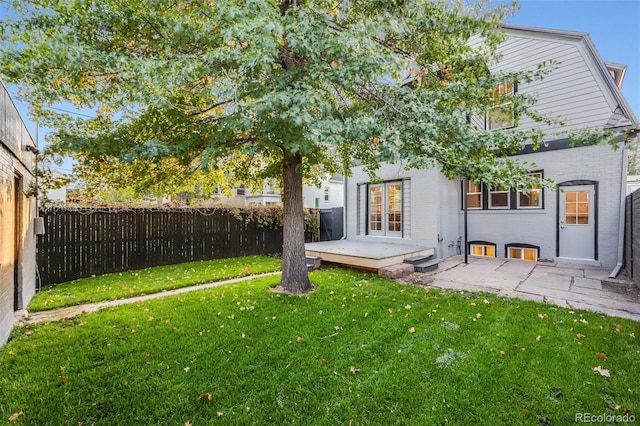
346,28,638,268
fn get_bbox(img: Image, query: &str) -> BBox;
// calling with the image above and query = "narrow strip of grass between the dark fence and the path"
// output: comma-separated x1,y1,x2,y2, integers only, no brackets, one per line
28,256,282,312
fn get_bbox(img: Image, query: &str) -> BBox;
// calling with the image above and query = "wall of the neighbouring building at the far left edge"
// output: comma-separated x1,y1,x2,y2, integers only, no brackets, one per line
0,82,37,345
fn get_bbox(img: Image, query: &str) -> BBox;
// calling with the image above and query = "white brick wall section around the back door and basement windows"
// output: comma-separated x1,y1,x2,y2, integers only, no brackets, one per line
457,145,626,268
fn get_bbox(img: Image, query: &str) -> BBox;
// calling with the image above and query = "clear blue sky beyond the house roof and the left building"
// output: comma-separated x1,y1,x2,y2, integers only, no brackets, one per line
10,0,640,171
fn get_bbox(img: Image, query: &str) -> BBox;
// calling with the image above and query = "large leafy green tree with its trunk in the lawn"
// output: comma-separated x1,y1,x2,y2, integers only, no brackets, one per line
0,0,552,293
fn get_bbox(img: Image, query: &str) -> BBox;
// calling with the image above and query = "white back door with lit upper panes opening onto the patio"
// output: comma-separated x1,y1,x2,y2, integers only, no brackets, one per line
558,185,596,260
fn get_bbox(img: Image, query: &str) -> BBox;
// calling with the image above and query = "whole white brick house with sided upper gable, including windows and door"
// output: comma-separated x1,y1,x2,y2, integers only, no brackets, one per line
345,25,639,273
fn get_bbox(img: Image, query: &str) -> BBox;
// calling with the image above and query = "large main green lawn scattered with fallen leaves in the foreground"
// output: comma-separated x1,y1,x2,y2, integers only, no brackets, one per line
0,269,640,425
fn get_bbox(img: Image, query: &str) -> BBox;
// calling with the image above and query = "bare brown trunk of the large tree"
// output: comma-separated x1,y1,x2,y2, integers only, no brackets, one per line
280,149,311,294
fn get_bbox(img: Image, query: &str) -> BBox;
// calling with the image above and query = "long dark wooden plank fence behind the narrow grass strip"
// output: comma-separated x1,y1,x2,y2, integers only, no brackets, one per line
37,208,317,285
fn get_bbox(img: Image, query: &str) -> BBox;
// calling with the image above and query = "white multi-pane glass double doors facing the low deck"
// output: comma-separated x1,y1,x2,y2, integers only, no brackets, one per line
367,182,402,237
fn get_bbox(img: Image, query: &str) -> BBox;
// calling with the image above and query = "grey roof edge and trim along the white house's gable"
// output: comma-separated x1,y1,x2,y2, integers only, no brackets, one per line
502,24,640,132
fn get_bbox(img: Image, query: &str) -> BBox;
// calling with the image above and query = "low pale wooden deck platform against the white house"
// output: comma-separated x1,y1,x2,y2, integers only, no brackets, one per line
305,240,435,270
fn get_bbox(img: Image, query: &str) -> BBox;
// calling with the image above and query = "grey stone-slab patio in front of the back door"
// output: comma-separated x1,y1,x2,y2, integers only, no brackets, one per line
398,256,640,321
